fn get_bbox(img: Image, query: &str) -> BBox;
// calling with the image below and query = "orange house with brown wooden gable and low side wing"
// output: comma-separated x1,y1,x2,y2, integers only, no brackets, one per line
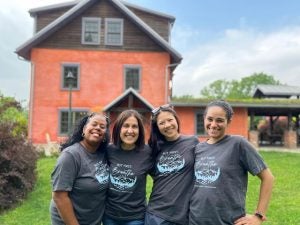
16,0,300,147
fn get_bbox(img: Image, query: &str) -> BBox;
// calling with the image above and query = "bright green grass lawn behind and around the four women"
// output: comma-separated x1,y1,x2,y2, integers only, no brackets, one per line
0,152,300,225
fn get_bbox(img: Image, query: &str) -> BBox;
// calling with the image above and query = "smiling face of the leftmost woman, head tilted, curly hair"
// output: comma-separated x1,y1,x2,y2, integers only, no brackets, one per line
82,114,107,150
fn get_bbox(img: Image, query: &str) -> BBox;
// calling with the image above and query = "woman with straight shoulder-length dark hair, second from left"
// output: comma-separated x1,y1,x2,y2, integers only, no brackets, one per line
103,110,153,225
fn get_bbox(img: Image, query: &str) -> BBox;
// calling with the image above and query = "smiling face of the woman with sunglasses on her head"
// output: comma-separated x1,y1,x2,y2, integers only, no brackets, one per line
157,111,179,141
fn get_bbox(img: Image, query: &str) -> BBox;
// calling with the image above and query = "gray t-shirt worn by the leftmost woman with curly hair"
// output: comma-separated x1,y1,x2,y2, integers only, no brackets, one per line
50,143,109,225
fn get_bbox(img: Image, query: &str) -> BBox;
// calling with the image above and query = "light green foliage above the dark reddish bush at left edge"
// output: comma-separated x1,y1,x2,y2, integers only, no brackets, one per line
0,94,28,136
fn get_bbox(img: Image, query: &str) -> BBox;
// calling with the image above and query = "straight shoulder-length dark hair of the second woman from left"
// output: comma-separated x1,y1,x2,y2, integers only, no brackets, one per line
112,109,145,149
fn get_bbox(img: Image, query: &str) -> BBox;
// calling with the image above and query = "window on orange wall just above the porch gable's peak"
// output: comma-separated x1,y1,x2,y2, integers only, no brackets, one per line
125,66,141,91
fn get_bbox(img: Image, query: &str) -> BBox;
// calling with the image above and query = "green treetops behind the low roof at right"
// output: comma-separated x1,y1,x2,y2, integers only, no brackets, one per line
200,73,280,99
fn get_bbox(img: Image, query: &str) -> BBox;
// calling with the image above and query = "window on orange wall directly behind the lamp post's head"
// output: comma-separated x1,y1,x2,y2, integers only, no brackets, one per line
62,64,79,90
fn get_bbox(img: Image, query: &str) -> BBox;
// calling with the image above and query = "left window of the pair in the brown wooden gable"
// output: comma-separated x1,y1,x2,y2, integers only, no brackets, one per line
81,17,101,45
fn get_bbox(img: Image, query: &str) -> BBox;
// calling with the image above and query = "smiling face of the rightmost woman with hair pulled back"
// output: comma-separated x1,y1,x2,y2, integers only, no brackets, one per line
204,106,230,144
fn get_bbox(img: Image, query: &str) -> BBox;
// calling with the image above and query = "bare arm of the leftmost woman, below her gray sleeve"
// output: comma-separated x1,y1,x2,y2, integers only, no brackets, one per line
52,191,79,225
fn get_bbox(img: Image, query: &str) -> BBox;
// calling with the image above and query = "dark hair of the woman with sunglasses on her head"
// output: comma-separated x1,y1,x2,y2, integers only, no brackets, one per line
148,106,180,157
